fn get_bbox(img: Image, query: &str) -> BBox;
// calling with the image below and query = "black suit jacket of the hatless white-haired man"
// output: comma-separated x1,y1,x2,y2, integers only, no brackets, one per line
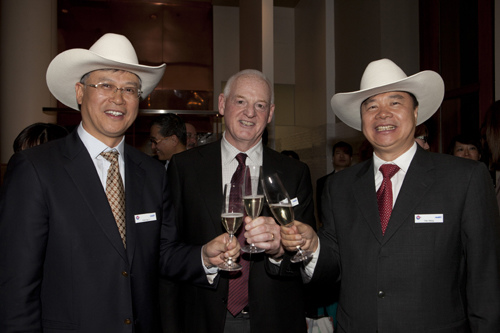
162,141,314,333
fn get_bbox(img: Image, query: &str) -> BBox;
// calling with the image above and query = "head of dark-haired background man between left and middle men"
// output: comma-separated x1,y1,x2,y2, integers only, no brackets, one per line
149,113,187,169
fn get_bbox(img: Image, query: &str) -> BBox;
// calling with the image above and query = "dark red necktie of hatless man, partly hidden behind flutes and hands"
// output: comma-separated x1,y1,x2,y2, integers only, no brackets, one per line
227,153,250,317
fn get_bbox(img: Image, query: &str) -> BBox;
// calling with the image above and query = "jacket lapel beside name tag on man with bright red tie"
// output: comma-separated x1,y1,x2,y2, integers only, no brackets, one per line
384,147,435,243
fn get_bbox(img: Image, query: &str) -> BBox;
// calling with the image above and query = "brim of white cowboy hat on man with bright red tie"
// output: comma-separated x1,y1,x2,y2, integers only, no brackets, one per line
331,71,444,131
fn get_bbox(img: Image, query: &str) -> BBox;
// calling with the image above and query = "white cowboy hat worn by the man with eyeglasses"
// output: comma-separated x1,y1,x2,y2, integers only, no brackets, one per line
46,34,166,110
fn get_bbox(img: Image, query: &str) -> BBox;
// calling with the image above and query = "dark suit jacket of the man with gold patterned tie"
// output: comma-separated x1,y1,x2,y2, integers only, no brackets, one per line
0,131,167,333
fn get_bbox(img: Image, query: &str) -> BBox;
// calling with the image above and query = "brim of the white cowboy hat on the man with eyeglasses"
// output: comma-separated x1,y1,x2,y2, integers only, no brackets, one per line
46,49,166,110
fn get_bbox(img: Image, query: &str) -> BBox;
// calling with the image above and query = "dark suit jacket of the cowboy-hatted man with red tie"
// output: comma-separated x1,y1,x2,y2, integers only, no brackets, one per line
313,147,500,333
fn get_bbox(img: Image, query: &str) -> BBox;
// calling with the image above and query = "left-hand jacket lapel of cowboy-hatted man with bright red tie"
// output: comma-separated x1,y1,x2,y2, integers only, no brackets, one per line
353,159,382,243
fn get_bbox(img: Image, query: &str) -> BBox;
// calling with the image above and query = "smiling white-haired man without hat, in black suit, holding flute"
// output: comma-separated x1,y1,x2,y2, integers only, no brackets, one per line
163,70,314,333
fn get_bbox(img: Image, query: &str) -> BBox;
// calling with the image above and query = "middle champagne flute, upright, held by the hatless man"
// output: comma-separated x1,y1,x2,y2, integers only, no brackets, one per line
241,165,265,253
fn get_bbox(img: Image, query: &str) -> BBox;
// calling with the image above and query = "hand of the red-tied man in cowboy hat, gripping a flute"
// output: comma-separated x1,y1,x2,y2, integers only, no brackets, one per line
281,221,318,252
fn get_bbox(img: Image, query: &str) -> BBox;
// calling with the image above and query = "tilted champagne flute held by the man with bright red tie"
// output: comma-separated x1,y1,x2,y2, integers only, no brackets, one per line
262,173,312,263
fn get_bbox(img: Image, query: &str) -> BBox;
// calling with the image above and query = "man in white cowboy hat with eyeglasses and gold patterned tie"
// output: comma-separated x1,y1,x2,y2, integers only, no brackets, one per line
0,34,239,333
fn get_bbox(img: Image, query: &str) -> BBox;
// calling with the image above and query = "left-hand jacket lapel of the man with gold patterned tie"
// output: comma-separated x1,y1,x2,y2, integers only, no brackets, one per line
63,130,127,260
